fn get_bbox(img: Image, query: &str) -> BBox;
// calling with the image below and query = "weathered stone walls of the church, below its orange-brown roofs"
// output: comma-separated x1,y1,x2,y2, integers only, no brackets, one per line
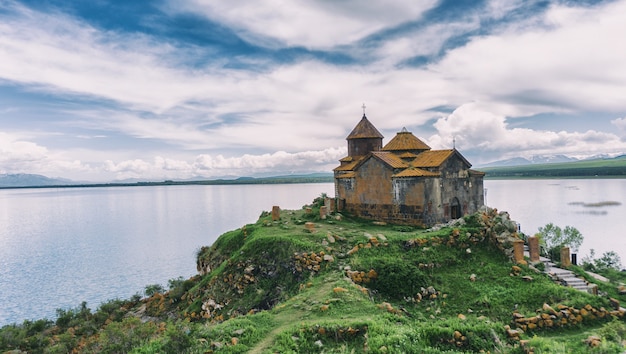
335,156,484,226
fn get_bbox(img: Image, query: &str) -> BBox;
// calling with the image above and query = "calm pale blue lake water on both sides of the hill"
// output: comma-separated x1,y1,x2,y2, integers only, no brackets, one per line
0,179,626,326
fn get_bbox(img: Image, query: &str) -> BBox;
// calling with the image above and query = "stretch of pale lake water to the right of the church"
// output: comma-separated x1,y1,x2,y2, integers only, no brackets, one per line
485,178,626,265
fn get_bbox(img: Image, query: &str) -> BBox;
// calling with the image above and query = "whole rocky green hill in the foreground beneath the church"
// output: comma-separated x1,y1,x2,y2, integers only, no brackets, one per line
0,200,626,353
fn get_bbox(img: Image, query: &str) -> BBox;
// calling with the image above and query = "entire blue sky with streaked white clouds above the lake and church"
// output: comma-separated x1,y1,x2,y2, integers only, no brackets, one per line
0,0,626,182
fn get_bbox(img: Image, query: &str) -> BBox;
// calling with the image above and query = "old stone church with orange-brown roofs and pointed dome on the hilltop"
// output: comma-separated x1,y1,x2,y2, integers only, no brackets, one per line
334,114,485,226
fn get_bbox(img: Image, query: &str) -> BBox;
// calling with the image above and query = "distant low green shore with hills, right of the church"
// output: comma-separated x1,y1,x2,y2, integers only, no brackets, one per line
480,155,626,178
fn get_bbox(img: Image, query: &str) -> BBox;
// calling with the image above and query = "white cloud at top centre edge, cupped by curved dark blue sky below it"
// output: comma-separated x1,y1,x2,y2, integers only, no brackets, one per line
170,0,438,49
